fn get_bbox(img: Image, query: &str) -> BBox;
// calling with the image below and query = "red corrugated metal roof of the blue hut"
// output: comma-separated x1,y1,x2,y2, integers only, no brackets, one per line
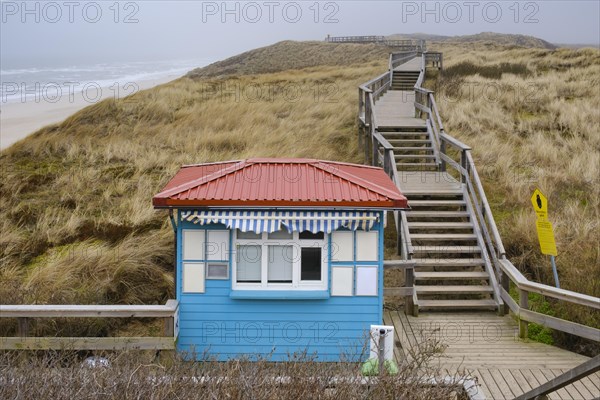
152,158,407,208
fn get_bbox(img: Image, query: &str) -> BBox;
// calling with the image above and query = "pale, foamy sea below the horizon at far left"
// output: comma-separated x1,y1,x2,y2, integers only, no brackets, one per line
0,58,215,103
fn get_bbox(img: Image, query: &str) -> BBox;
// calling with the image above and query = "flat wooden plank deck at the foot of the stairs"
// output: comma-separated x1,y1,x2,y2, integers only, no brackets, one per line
384,311,600,400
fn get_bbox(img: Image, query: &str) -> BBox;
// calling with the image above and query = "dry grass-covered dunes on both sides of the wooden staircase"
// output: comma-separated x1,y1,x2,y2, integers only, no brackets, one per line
0,42,600,348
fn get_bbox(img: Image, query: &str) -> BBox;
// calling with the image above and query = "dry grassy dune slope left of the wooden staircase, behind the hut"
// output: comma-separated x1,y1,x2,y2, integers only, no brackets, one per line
0,43,388,335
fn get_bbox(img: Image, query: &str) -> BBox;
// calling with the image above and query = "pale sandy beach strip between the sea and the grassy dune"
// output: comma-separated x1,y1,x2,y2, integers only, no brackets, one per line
0,75,179,149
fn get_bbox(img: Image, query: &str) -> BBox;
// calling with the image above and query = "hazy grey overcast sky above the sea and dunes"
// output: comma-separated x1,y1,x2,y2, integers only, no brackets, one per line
0,0,600,69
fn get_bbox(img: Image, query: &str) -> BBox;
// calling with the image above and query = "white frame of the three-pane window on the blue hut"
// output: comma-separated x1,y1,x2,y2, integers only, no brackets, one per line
231,230,329,290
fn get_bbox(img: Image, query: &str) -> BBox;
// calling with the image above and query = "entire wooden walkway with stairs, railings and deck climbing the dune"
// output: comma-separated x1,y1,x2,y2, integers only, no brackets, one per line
359,50,600,400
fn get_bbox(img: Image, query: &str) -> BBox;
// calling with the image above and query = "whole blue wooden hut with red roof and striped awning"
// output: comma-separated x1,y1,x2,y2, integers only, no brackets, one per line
153,159,407,361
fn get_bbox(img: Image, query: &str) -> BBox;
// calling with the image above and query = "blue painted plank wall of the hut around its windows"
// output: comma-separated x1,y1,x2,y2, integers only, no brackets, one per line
176,212,383,361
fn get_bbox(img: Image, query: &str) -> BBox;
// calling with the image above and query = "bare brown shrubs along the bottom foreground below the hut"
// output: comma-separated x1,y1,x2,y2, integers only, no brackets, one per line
0,338,467,400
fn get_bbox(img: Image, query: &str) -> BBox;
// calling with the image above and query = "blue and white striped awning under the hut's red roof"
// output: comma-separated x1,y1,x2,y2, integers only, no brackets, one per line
181,210,378,233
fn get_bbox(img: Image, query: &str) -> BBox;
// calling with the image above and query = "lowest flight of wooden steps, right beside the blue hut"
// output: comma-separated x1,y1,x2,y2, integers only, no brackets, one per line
406,190,497,310
